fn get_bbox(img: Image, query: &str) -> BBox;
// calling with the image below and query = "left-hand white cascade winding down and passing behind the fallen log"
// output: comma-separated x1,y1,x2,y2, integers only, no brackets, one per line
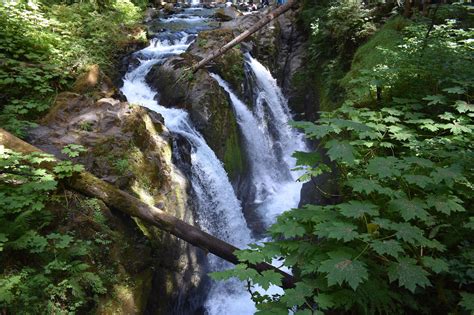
118,27,255,314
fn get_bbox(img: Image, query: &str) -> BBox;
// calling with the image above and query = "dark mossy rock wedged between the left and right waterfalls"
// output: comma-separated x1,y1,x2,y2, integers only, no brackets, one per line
147,57,245,178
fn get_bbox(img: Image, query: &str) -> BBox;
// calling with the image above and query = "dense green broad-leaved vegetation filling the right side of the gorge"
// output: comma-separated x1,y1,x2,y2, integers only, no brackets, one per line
214,1,474,314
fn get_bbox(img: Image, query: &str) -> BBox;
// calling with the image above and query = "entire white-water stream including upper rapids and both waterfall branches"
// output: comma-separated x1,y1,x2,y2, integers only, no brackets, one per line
121,8,306,315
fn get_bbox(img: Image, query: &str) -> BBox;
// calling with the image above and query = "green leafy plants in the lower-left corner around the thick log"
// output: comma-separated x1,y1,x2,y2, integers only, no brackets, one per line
0,149,110,314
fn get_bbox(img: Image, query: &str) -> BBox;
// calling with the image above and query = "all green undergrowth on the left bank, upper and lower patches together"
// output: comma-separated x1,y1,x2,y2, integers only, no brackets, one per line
0,0,147,314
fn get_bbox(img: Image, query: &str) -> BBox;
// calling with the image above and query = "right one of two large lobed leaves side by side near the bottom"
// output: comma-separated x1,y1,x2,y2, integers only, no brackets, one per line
388,257,431,293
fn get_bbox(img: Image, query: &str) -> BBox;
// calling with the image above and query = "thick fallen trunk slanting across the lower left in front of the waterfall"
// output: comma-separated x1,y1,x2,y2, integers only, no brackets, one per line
0,128,295,288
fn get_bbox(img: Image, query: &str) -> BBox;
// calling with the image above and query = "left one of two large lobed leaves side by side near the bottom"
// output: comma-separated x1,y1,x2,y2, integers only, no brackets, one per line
318,251,369,290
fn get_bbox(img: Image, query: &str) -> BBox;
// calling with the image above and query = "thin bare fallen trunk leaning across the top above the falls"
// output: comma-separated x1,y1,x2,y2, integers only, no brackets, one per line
191,0,297,73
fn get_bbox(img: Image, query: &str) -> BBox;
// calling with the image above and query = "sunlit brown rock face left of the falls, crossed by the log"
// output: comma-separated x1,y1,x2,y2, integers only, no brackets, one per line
29,93,205,314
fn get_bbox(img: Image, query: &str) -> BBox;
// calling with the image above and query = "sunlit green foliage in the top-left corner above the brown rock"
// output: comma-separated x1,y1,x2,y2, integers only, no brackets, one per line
0,0,145,136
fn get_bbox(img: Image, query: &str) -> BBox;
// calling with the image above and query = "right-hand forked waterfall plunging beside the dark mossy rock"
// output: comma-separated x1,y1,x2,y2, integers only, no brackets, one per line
212,54,307,231
